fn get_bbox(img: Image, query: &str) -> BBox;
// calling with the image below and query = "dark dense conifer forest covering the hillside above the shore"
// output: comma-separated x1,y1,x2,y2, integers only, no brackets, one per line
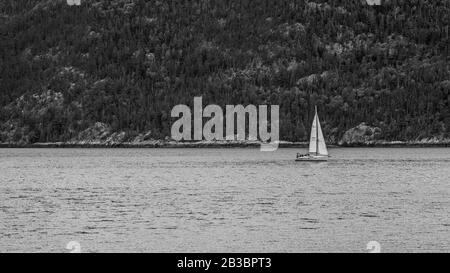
0,0,450,143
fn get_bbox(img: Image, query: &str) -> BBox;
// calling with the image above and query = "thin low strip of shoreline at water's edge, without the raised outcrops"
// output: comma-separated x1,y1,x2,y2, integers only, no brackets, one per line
0,141,450,149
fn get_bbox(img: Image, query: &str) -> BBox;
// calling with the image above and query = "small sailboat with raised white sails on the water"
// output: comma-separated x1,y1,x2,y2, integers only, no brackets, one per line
295,106,328,161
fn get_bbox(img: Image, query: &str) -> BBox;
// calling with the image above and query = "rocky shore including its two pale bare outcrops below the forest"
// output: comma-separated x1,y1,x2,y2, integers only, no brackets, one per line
0,122,450,148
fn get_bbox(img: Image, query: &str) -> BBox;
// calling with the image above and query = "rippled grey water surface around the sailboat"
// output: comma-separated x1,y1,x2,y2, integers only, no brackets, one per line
0,148,450,252
